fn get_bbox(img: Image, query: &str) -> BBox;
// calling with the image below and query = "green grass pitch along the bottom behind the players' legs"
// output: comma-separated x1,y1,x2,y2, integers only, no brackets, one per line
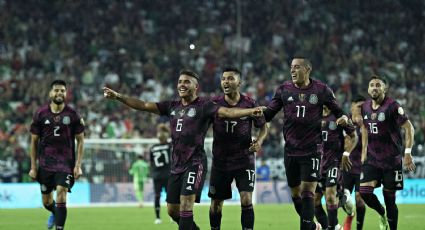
0,204,425,230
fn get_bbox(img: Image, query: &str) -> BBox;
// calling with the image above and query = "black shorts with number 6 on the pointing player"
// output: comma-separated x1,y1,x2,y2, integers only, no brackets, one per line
167,163,207,204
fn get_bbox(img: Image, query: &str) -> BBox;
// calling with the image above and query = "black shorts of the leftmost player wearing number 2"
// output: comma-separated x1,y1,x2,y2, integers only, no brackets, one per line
37,168,75,194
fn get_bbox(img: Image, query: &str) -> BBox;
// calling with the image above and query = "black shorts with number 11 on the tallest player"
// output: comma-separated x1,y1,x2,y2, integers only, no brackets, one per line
284,153,320,188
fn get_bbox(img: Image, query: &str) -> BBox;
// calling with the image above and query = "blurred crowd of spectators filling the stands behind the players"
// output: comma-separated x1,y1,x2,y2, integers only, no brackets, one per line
0,0,425,182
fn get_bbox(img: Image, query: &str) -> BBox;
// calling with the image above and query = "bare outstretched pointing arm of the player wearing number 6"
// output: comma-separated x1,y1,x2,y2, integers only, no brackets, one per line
103,87,159,114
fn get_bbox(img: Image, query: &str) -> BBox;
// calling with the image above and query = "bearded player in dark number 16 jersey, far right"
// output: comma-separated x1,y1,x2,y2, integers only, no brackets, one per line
360,75,415,230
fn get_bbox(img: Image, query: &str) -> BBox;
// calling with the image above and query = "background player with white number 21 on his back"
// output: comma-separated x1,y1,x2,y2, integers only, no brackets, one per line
150,124,171,224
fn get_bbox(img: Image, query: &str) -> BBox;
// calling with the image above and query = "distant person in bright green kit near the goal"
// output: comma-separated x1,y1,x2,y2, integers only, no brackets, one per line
128,154,149,207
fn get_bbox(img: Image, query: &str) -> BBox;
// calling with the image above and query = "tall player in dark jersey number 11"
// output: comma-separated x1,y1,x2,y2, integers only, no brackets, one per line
264,58,348,230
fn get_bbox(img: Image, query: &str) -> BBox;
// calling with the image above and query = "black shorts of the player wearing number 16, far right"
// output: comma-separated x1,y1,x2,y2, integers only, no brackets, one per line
360,164,404,190
